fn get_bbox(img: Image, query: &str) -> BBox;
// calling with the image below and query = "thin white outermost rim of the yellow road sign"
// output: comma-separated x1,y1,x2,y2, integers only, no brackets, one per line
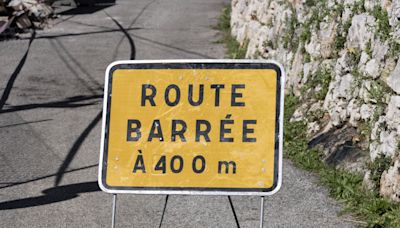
98,59,286,196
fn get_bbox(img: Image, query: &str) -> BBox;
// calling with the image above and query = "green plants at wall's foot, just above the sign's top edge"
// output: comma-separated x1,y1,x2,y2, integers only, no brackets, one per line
214,7,248,59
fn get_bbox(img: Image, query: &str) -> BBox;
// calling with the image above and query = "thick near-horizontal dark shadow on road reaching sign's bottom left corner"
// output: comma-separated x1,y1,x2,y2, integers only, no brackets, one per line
0,181,100,210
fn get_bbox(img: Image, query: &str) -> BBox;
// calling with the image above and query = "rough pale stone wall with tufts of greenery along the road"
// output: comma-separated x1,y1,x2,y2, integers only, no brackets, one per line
231,0,400,202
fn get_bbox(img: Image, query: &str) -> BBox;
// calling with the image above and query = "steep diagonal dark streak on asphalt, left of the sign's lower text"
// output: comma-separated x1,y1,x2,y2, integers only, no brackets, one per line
54,111,102,186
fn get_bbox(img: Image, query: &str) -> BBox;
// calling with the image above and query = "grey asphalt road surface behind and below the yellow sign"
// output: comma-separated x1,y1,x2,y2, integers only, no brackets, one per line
0,0,354,227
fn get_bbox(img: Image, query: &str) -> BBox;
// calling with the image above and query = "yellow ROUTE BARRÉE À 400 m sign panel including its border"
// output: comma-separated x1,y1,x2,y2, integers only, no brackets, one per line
99,60,284,195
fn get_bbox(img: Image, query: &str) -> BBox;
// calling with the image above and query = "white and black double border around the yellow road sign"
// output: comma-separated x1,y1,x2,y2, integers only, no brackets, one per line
98,59,285,196
